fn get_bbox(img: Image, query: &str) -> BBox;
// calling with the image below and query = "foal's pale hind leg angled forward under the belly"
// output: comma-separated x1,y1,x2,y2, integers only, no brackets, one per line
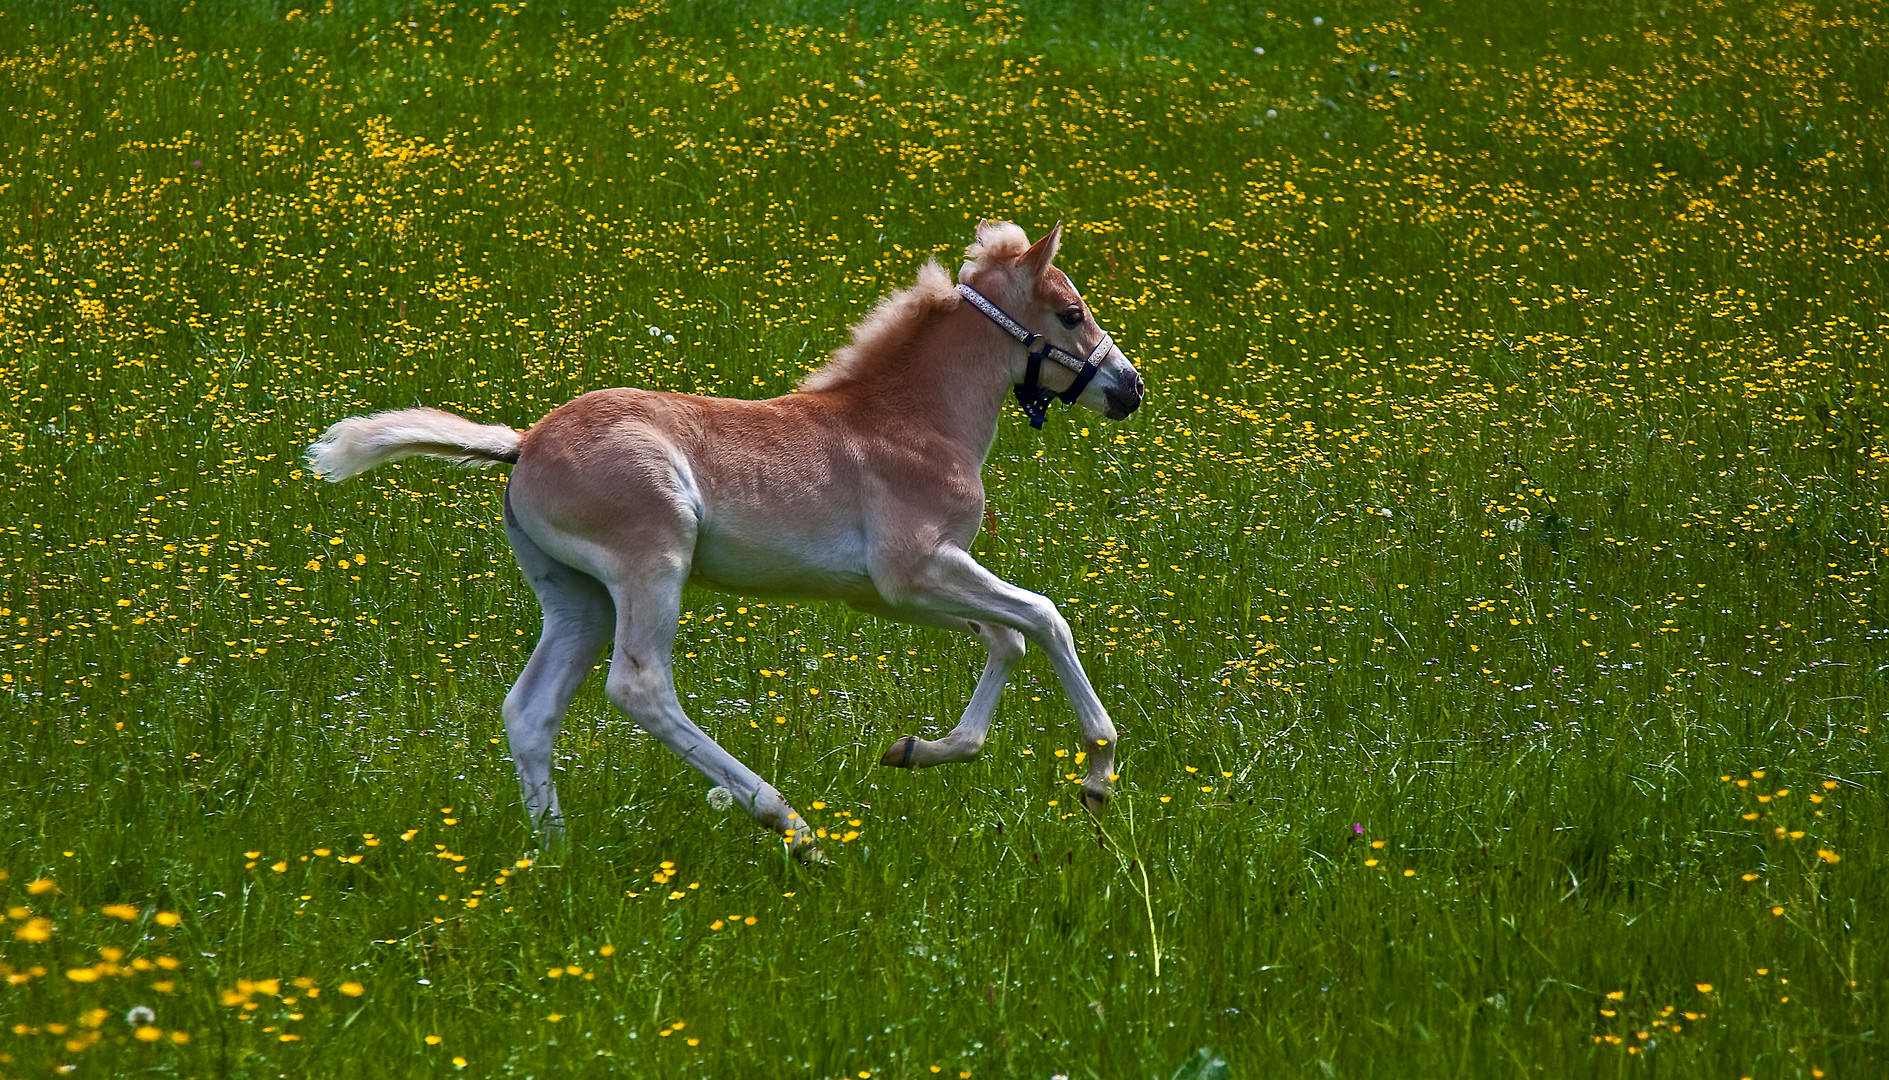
604,566,822,861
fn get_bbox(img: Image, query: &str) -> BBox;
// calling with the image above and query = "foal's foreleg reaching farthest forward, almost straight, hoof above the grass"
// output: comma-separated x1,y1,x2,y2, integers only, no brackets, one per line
888,544,1115,810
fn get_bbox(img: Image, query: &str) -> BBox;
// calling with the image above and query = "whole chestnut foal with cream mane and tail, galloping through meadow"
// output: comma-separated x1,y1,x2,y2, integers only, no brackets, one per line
308,221,1143,859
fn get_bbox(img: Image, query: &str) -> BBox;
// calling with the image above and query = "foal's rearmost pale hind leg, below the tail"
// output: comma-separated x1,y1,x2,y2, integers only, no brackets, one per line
504,502,614,844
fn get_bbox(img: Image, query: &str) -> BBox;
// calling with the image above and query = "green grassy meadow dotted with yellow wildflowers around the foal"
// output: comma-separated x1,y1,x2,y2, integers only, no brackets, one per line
0,0,1889,1080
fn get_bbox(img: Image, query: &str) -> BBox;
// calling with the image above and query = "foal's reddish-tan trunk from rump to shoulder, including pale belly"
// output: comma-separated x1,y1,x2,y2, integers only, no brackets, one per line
510,389,980,599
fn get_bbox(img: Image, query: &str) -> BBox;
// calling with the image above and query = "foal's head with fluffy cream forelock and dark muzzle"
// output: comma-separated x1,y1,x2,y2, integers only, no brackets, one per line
958,221,1145,419
